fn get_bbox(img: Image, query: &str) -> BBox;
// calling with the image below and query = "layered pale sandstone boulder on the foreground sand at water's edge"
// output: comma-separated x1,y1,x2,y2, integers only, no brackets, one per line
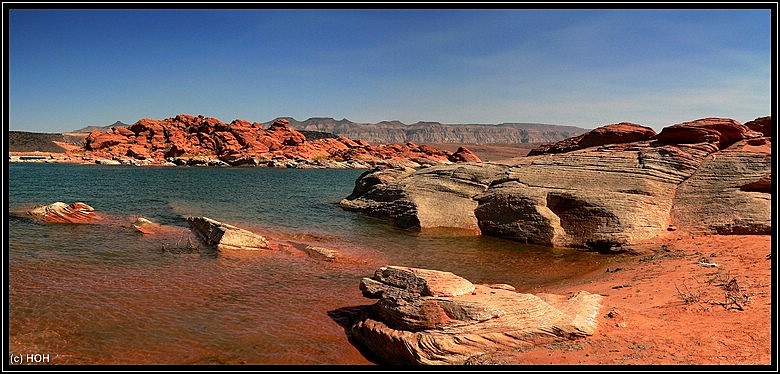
349,266,602,364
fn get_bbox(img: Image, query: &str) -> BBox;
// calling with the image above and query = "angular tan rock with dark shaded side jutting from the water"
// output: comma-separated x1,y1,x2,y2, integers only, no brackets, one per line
187,217,269,250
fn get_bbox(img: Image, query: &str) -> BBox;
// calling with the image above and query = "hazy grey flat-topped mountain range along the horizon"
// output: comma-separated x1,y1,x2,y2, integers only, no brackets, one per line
73,117,589,144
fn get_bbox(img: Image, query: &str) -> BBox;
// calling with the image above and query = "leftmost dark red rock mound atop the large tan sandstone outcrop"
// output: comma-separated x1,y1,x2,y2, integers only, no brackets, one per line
528,122,656,156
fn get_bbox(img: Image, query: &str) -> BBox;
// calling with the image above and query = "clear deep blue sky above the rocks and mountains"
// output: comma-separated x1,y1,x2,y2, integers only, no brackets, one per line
7,9,773,132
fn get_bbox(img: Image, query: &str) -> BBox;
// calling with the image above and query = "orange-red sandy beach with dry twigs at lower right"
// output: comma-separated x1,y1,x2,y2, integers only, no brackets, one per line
474,232,777,371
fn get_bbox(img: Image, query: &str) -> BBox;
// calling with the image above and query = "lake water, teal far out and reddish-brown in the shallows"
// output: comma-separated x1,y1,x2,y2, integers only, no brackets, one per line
6,163,609,365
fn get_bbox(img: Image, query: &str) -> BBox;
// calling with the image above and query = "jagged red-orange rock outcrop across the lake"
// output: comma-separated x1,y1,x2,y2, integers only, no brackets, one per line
79,114,478,168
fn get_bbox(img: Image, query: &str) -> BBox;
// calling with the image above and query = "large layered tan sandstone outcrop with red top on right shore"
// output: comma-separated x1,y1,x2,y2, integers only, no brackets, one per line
340,117,772,250
